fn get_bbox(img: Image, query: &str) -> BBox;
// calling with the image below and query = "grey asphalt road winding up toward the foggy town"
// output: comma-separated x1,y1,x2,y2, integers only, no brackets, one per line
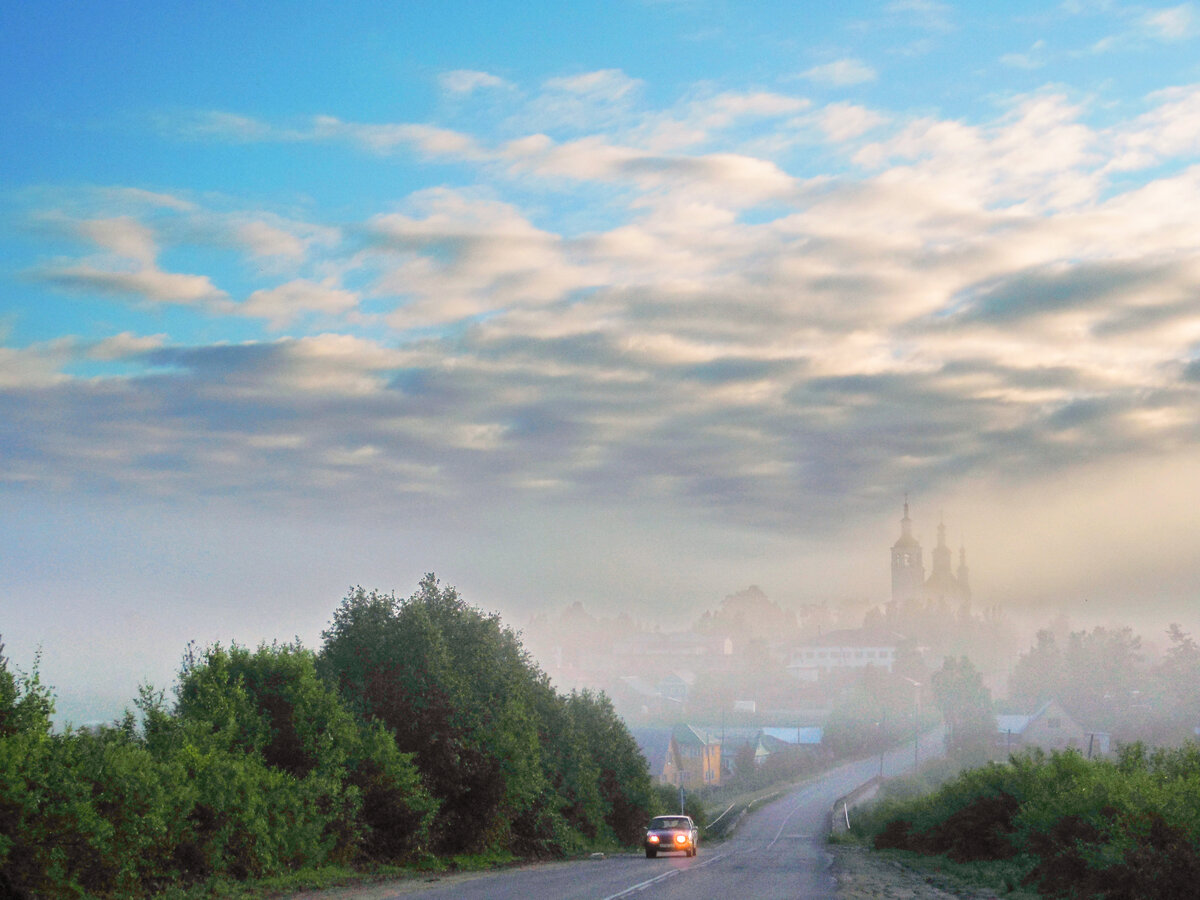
319,734,942,900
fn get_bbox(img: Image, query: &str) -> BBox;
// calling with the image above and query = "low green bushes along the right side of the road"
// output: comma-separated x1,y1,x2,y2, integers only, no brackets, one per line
854,744,1200,900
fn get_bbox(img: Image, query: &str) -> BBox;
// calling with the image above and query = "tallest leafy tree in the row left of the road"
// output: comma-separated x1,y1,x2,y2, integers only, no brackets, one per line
322,575,547,852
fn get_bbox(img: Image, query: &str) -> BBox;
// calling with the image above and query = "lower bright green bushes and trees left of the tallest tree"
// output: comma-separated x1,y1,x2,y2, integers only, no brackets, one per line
0,644,432,898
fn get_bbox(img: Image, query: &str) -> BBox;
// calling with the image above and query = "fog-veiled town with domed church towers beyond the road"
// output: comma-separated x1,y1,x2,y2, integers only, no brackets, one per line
524,498,1190,785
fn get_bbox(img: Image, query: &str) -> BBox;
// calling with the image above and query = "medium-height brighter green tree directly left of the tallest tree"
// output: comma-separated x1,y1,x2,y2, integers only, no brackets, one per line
169,643,433,872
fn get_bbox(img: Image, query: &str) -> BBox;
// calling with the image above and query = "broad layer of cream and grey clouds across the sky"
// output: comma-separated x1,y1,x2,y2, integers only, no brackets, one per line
7,72,1200,542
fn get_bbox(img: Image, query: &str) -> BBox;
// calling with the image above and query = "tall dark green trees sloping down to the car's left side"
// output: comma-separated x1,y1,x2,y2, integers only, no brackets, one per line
320,575,650,854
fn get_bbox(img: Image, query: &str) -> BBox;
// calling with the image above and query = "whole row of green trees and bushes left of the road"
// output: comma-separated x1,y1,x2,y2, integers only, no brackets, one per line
0,575,656,898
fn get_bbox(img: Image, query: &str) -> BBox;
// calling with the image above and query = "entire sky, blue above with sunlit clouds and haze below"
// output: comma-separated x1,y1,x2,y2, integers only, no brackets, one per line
0,0,1200,719
